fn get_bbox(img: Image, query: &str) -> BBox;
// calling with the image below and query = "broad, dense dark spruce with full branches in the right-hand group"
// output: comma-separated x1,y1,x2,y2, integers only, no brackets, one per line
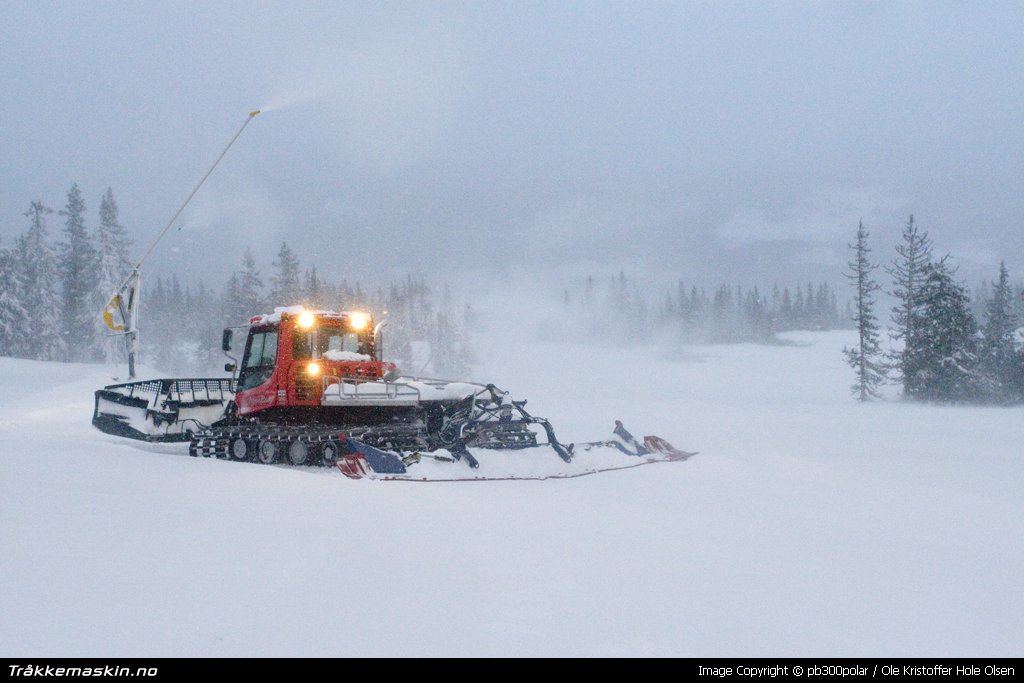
903,258,982,402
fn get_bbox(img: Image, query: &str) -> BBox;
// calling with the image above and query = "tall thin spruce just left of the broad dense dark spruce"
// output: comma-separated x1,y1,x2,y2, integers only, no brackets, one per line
886,215,932,395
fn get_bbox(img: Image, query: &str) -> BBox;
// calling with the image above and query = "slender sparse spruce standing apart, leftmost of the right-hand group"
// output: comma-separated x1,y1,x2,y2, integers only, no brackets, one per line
843,222,886,401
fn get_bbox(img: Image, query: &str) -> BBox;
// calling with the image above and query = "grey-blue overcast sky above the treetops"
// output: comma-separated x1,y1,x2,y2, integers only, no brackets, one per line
0,0,1024,287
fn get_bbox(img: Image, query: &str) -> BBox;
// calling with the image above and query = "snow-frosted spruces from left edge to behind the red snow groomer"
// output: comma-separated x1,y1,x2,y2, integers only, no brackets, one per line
0,189,474,377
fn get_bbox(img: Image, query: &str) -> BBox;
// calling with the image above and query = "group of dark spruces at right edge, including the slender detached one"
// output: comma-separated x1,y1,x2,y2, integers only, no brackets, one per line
844,216,1024,404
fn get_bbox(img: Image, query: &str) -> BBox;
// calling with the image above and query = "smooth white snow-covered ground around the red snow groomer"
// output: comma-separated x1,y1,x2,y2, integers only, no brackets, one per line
0,333,1024,656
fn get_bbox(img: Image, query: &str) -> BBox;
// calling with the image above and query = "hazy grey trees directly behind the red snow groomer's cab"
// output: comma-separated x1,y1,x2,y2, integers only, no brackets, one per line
140,243,475,377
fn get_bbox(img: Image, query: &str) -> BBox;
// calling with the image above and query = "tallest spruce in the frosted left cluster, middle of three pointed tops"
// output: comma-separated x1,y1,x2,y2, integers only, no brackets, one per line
59,183,100,360
